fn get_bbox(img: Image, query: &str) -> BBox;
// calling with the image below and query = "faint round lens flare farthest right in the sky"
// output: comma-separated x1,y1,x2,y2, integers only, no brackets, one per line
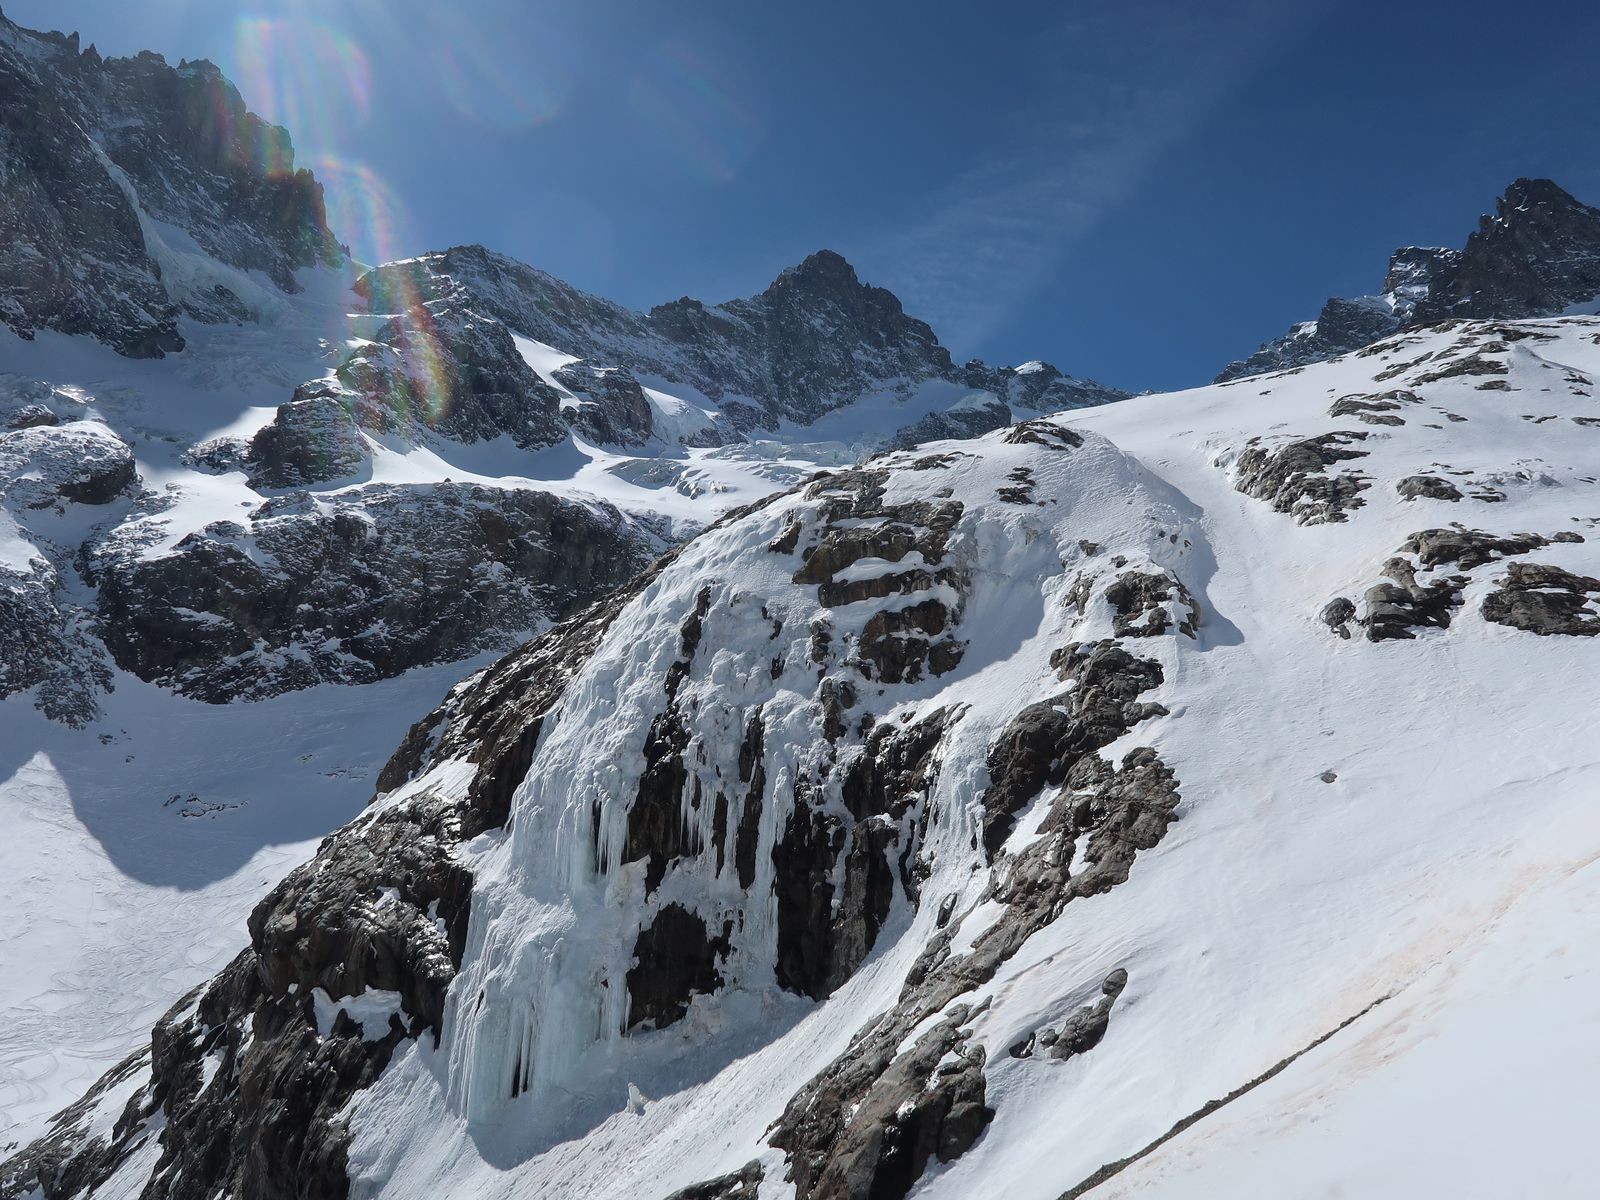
629,38,766,182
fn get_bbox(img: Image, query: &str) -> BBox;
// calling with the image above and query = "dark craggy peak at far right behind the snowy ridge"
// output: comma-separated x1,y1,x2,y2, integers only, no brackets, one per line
1216,179,1600,382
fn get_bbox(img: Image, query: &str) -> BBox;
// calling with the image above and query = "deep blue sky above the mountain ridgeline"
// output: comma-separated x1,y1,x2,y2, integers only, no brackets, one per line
21,0,1600,389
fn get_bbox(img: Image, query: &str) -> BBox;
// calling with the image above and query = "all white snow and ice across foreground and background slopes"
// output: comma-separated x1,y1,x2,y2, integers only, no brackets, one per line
0,260,1600,1200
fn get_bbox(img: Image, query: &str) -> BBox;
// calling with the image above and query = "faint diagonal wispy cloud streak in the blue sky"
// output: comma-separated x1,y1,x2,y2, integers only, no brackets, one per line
856,0,1326,352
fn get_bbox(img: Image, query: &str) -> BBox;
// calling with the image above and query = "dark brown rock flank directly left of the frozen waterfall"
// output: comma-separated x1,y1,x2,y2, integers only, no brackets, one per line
0,573,665,1200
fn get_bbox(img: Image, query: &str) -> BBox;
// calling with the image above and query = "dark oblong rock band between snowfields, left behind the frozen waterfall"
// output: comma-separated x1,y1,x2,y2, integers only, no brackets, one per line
96,483,659,702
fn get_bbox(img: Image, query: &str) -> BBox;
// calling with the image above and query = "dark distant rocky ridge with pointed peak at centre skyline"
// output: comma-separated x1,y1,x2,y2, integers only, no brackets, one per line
353,246,1128,445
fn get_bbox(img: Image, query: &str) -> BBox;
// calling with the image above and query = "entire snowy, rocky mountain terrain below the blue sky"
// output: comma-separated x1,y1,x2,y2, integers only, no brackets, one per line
0,7,1600,1200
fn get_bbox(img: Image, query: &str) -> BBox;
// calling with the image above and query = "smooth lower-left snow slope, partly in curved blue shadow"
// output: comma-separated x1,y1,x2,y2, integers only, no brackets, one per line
0,662,492,1149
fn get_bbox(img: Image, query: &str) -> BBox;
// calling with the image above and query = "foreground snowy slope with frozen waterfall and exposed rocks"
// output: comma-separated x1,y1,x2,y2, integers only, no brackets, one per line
0,317,1600,1200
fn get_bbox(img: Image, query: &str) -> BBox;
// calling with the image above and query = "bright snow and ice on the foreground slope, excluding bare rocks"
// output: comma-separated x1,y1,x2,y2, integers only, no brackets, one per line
321,317,1600,1200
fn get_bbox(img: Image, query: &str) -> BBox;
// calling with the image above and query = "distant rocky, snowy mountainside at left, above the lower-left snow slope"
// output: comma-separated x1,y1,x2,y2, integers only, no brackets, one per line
0,4,1126,725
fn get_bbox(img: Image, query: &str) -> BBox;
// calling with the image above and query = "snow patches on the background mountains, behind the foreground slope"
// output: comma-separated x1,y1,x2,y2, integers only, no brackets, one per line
0,240,1113,1149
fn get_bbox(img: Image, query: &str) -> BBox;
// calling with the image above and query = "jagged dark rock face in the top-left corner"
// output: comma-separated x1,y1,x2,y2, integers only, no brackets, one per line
0,18,339,357
